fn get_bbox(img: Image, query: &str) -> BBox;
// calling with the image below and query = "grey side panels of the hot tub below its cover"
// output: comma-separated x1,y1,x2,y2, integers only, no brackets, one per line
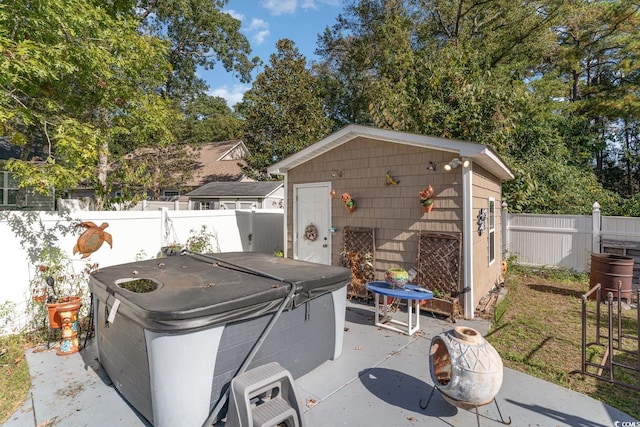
94,286,346,426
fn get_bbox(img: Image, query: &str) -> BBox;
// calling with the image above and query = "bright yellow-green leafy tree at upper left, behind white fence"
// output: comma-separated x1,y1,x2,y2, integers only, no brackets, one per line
0,0,168,207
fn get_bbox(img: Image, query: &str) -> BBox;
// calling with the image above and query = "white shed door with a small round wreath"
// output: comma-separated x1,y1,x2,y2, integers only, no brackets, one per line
293,182,331,265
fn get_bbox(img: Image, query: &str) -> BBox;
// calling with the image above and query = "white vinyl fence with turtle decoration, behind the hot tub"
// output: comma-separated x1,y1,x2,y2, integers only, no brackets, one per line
0,209,284,331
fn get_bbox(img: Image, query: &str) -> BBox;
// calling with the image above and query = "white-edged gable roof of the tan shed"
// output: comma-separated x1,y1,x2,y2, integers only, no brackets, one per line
267,125,514,180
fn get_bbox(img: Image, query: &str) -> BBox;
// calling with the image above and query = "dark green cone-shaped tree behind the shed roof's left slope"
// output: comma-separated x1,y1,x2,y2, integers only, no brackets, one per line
238,39,331,180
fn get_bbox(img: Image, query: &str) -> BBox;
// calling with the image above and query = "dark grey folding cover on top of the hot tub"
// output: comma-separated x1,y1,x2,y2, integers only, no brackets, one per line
89,252,351,331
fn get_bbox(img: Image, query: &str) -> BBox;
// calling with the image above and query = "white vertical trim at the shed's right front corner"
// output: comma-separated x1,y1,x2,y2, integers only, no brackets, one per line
462,162,475,319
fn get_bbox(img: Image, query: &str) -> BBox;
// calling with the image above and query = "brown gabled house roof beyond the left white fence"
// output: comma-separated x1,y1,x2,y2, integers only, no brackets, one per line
184,140,249,187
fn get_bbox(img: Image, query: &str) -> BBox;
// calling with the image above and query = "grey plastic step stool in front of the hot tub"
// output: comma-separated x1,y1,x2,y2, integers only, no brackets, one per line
225,362,304,427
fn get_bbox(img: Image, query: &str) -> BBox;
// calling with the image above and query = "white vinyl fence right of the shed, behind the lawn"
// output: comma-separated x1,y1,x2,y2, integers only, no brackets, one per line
502,203,640,272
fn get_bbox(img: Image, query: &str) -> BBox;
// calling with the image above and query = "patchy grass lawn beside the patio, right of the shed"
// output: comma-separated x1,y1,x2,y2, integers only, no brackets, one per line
487,267,640,419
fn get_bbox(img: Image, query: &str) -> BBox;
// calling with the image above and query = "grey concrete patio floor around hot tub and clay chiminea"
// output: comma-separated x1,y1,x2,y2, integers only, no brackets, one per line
4,301,640,427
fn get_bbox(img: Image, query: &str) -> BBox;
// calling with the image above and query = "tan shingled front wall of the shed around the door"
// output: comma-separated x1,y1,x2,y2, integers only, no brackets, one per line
287,138,462,280
